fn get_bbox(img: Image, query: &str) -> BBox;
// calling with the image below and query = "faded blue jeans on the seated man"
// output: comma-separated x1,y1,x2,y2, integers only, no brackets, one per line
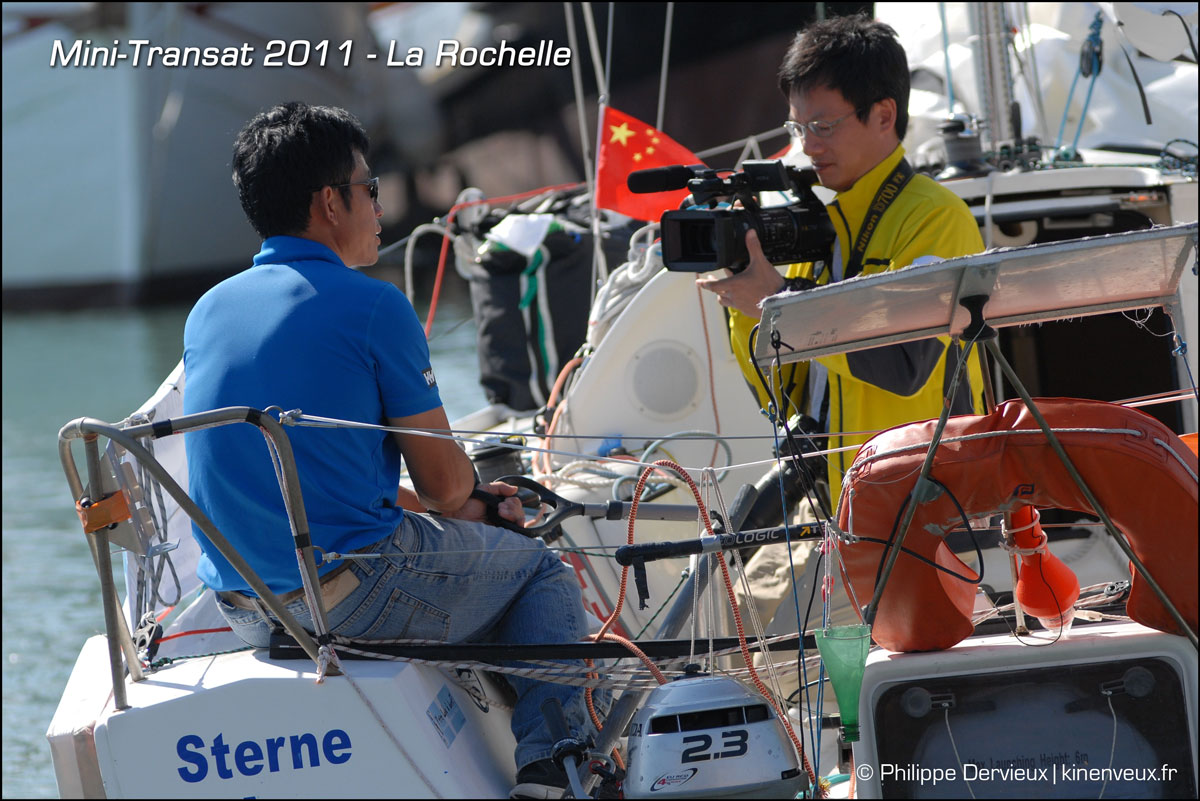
217,513,611,769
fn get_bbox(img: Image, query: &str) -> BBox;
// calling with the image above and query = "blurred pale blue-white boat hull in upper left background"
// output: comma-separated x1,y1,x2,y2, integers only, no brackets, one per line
4,2,440,308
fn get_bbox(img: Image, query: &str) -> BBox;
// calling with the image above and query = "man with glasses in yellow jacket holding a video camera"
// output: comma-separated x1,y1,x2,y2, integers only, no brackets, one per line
697,16,983,642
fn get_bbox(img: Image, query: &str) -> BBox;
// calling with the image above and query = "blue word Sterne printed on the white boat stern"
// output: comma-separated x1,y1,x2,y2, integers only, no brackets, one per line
175,729,353,783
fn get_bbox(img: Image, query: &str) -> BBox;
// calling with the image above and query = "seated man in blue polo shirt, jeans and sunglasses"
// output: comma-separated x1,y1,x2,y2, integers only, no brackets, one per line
184,103,600,797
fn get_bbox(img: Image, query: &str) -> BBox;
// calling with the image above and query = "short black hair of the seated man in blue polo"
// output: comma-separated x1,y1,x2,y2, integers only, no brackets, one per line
233,102,370,239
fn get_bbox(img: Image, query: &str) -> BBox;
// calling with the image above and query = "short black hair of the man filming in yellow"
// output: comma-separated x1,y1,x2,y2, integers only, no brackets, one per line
779,14,908,139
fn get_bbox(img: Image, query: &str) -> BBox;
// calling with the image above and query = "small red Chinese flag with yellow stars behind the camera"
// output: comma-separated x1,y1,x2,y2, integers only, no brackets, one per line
596,106,703,222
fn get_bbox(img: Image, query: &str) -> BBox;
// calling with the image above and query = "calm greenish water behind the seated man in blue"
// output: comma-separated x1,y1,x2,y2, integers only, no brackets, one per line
0,291,485,797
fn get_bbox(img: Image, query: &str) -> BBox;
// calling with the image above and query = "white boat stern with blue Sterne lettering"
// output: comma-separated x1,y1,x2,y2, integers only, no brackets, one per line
49,637,515,799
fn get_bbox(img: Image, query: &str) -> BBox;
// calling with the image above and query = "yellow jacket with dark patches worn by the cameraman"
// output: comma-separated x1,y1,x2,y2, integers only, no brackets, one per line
730,146,983,499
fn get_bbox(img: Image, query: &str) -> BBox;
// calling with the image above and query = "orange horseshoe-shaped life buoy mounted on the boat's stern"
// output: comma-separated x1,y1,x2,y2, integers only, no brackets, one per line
838,398,1198,651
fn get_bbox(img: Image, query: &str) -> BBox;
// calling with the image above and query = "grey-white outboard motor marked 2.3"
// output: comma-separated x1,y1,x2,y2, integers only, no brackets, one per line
623,676,808,799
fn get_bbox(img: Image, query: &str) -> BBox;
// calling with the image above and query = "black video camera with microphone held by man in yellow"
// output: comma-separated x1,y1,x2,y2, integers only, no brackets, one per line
628,159,836,272
